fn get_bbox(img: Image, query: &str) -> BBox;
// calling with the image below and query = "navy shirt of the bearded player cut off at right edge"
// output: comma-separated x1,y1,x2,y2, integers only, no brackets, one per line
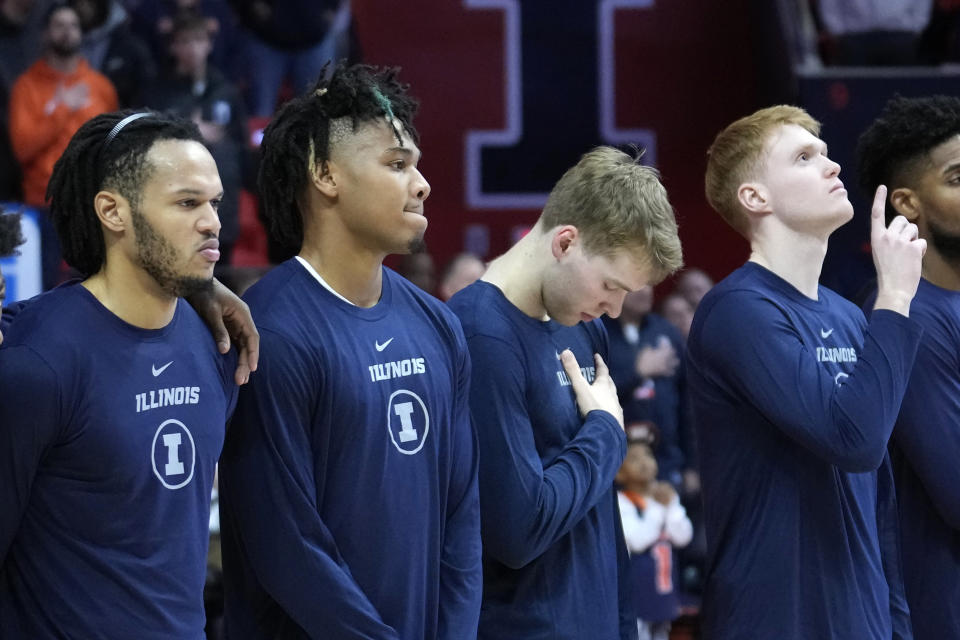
872,279,960,640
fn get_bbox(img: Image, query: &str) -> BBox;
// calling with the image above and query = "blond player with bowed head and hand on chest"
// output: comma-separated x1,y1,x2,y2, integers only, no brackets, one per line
449,147,681,640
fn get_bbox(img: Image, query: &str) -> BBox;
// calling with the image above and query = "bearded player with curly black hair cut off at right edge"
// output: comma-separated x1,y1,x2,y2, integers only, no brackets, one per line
859,96,960,640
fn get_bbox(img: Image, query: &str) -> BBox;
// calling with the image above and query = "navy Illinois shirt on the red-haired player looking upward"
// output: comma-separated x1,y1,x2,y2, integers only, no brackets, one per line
687,263,922,640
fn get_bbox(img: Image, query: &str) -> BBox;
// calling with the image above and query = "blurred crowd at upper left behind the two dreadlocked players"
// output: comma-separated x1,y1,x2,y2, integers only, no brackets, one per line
0,0,358,288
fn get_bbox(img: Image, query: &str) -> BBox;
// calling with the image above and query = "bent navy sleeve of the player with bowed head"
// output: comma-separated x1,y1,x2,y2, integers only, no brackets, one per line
469,335,626,569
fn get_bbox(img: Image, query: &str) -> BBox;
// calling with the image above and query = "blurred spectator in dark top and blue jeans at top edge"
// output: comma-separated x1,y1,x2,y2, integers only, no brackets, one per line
230,0,351,117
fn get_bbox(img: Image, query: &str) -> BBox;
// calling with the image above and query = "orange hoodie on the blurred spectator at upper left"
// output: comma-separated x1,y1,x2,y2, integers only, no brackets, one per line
10,58,117,206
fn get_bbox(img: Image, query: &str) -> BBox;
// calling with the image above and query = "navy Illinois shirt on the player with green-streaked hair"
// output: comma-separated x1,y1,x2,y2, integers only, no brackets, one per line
220,259,482,640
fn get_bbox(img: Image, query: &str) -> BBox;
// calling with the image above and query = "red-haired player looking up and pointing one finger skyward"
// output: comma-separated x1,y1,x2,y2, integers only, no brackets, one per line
687,106,925,640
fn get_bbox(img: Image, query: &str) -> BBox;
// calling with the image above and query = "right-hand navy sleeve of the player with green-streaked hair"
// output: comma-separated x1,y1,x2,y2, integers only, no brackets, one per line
437,331,483,640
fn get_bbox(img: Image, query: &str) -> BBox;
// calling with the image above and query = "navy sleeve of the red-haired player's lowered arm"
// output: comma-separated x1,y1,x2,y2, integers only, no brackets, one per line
877,456,913,640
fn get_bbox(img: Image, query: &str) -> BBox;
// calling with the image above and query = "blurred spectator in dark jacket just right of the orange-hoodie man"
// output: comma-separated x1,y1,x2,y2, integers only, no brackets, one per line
70,0,157,107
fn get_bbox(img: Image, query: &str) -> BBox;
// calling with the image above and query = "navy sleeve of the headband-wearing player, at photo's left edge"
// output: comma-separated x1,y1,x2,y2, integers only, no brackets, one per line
0,346,61,567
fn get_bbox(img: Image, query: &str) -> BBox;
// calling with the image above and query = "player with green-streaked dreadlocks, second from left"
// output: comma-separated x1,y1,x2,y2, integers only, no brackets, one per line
220,65,481,639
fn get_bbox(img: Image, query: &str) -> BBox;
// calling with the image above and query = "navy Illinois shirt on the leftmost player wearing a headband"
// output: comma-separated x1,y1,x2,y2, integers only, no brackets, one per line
0,284,237,640
